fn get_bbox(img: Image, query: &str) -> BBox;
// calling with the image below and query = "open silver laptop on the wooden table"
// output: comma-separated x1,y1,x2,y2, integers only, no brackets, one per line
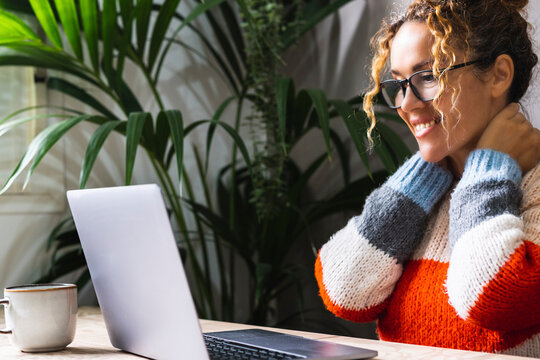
67,184,377,360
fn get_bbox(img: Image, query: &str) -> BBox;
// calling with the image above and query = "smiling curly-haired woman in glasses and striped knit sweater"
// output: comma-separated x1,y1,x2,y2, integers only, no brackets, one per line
315,0,540,356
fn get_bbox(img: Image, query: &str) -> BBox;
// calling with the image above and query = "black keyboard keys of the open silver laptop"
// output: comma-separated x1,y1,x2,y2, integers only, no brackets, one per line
203,334,303,360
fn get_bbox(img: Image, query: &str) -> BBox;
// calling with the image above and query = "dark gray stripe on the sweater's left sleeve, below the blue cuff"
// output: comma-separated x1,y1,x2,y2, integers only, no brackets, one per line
355,186,427,263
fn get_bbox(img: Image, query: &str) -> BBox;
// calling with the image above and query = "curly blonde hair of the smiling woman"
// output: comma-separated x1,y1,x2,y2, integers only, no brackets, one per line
363,0,538,145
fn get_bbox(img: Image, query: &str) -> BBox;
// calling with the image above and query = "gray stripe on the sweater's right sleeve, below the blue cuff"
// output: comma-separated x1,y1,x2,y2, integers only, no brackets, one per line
449,180,522,248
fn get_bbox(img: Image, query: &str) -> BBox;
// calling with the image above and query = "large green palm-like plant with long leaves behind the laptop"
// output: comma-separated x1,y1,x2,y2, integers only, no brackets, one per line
0,0,408,323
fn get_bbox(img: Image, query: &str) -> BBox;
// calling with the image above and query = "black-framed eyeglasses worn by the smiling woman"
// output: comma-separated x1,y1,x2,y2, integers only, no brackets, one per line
380,59,484,109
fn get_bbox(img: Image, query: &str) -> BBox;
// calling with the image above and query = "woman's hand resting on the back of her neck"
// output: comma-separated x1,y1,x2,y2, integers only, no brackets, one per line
476,103,540,172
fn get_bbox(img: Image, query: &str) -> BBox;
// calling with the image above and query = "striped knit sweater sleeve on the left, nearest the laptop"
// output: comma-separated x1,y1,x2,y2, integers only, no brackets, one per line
315,153,452,322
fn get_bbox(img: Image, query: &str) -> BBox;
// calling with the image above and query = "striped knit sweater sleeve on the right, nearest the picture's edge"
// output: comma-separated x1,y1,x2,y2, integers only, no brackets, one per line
447,149,540,331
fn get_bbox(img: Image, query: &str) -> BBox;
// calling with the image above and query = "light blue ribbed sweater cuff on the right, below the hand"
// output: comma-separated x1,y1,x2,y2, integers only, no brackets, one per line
457,149,522,189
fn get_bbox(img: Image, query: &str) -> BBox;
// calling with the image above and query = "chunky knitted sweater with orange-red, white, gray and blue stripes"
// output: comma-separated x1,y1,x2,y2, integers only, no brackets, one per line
315,150,540,357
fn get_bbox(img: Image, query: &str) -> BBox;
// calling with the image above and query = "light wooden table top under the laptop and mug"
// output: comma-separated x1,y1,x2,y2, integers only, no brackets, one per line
0,307,531,360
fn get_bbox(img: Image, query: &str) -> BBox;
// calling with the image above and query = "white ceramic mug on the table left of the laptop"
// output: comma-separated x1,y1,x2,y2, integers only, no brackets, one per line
0,284,77,352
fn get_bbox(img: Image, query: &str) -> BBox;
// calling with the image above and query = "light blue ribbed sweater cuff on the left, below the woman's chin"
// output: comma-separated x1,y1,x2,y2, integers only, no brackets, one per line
385,152,452,213
